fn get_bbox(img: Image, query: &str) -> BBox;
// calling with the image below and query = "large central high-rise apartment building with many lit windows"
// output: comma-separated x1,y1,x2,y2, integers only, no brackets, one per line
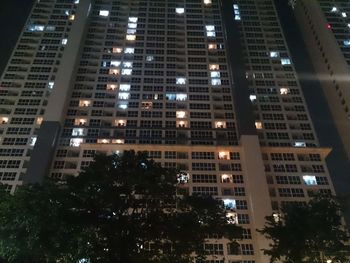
0,0,333,263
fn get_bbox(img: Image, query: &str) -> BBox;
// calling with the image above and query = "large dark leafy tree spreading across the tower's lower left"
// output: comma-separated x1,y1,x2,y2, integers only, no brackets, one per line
0,151,241,263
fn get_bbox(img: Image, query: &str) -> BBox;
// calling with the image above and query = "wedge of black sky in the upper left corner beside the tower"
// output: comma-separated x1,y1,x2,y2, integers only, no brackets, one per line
0,0,33,73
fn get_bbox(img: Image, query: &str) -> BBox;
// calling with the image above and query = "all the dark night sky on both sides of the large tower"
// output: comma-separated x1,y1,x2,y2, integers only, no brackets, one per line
0,0,350,221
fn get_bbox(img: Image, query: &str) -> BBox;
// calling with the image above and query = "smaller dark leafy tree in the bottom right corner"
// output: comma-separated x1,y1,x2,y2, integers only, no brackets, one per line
259,196,350,263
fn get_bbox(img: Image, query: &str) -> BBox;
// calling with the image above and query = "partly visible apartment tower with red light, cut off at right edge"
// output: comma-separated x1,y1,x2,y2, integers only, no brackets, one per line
295,0,350,159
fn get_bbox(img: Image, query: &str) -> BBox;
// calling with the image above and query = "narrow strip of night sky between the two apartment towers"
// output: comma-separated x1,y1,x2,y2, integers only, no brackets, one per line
275,0,350,226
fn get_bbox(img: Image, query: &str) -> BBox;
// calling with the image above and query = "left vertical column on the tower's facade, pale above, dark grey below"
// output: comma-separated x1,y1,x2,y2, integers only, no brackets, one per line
24,0,91,183
